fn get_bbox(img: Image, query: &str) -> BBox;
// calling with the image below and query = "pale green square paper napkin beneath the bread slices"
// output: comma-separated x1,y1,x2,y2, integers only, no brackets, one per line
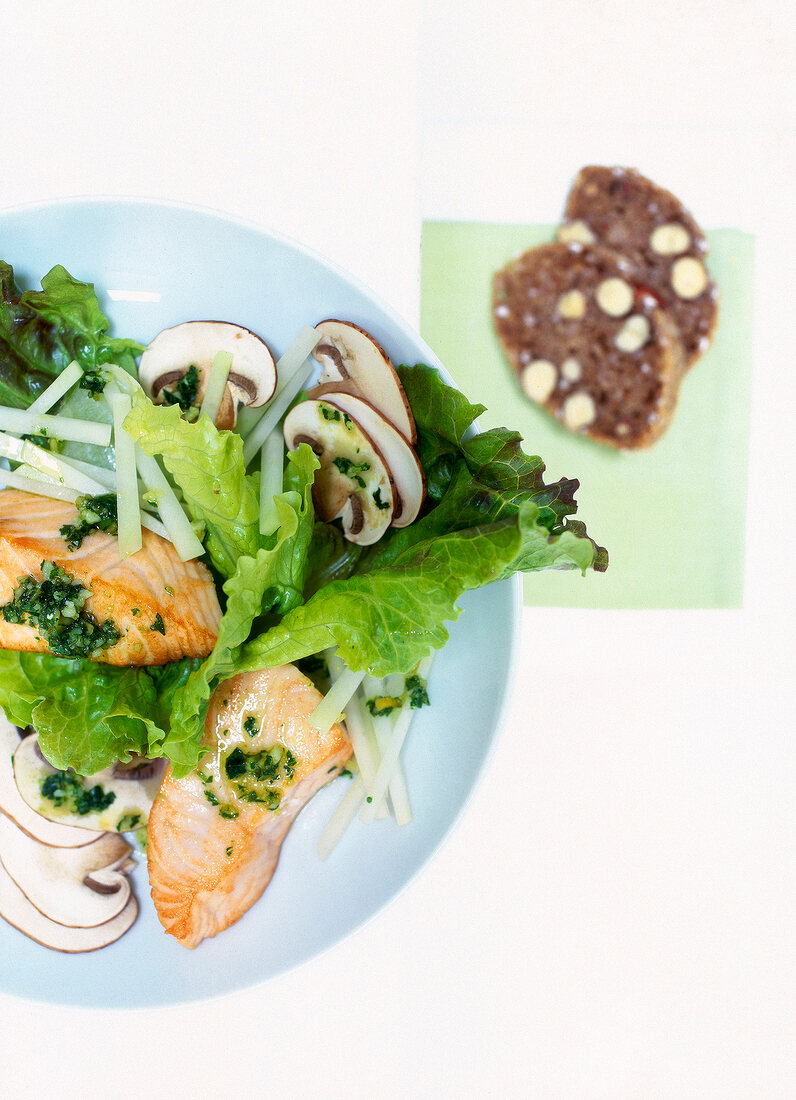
421,221,754,608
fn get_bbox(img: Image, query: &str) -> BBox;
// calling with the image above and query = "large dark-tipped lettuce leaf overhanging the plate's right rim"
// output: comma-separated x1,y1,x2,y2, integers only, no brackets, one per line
237,364,608,677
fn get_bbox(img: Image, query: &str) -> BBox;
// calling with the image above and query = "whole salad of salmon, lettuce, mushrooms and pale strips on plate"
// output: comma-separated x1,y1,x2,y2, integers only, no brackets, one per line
0,263,607,952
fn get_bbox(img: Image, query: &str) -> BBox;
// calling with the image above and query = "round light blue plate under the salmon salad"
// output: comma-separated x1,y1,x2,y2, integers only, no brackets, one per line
0,199,521,1008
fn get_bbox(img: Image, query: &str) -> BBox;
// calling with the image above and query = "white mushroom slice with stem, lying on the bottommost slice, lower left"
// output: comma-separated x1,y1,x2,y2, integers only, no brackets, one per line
0,817,132,928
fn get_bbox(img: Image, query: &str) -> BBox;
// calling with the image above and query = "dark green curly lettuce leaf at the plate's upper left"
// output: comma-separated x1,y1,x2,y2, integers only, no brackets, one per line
0,261,143,408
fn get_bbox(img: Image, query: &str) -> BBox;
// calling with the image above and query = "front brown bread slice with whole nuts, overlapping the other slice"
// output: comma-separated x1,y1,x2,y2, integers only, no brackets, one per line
493,243,685,450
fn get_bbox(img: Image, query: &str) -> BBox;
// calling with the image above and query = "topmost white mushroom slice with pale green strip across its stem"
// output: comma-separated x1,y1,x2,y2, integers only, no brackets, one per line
139,321,276,429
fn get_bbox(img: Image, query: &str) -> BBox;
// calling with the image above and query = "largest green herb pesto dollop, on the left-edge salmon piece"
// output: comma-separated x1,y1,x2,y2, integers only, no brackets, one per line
0,561,121,657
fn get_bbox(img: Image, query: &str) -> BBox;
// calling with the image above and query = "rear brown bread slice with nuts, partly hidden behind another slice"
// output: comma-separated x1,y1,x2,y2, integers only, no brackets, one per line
559,165,718,366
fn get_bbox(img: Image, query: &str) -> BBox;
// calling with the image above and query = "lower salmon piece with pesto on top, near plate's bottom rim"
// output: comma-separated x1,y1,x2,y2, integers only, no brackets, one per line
146,664,351,947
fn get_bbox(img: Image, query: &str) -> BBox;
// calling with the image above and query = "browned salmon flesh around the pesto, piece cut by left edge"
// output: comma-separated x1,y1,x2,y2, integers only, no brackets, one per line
0,488,221,666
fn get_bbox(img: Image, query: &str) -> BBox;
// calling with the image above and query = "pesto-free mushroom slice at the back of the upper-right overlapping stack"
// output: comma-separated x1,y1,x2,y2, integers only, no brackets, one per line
313,319,418,443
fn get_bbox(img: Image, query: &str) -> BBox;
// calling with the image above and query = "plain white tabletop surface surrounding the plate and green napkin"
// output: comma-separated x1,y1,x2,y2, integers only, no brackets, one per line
0,0,796,1100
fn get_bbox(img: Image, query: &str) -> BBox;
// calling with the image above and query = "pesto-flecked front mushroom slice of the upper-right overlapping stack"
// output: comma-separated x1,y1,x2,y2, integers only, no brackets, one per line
284,400,395,546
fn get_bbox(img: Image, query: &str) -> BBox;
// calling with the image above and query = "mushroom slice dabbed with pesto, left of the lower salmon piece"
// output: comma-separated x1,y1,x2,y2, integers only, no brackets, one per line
13,735,166,833
